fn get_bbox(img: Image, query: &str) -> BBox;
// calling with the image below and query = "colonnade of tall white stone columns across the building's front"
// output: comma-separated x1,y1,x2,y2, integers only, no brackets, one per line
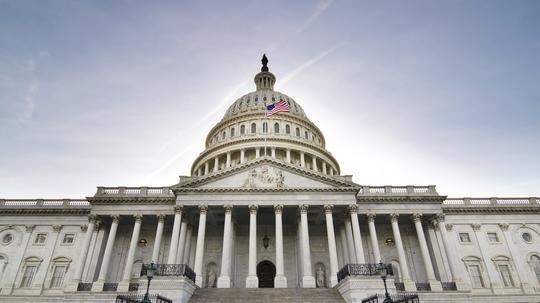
73,204,460,291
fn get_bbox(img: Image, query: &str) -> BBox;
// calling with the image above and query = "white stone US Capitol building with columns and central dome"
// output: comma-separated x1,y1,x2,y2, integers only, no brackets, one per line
0,58,540,302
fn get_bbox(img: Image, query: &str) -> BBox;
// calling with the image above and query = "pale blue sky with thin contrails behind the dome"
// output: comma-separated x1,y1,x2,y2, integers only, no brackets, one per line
0,0,540,198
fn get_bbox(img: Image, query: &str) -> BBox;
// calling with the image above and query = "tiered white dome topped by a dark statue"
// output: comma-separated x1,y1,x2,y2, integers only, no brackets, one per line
191,56,340,176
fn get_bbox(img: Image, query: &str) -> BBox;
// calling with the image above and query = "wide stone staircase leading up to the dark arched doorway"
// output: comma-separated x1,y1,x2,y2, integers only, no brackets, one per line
189,288,345,303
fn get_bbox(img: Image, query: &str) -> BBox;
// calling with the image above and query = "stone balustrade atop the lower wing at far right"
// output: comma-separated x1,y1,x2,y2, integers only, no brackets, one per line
443,197,540,208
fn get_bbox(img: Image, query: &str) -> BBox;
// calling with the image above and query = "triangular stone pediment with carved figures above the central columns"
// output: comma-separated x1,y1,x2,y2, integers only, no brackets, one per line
176,158,358,189
